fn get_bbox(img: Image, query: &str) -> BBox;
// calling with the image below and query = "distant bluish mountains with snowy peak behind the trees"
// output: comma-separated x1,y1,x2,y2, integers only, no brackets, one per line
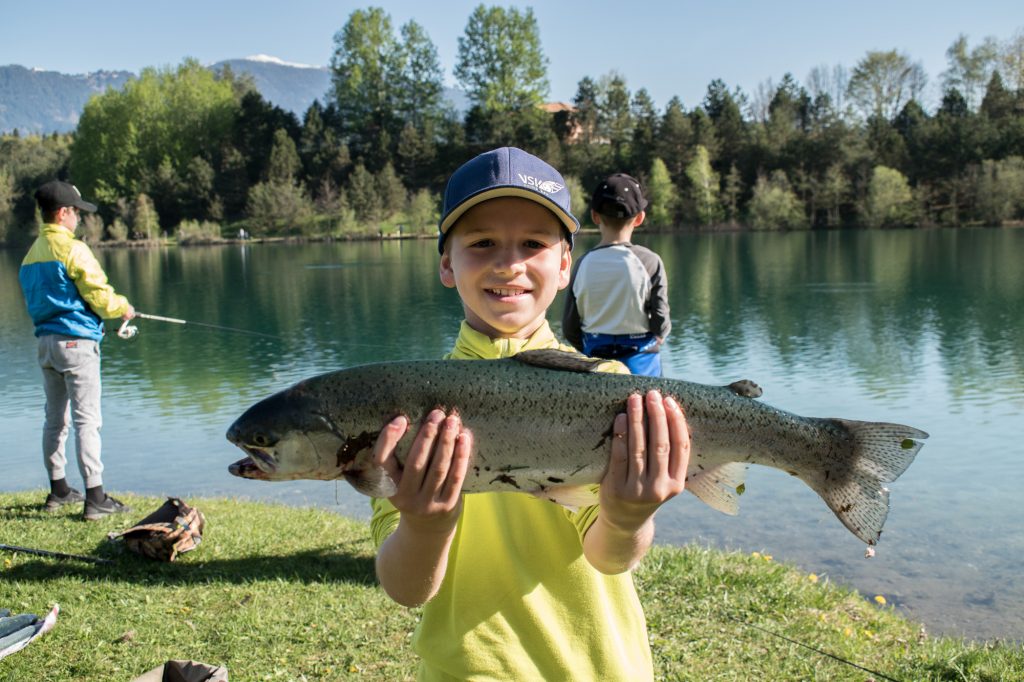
0,54,466,134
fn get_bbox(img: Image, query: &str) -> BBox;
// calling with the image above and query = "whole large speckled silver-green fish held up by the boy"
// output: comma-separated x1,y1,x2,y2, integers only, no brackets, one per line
227,350,928,545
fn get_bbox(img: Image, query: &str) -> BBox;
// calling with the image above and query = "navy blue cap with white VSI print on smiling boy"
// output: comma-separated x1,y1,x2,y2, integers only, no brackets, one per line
437,146,580,253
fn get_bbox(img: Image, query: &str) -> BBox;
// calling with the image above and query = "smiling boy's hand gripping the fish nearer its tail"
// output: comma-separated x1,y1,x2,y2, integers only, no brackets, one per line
600,390,690,532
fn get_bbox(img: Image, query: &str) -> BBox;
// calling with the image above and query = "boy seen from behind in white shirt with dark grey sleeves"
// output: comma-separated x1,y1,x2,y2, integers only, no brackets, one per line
562,173,672,377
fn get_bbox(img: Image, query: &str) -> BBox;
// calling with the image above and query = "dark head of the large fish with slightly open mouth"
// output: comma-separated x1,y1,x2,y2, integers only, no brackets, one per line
227,384,348,480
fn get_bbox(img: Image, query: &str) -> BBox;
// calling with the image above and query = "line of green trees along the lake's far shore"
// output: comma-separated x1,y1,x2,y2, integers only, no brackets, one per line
0,5,1024,244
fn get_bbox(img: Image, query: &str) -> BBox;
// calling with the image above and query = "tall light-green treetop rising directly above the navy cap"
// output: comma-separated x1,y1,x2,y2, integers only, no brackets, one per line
455,4,548,116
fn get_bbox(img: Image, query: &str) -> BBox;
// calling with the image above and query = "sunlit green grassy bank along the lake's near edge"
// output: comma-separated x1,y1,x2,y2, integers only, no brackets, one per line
0,491,1024,682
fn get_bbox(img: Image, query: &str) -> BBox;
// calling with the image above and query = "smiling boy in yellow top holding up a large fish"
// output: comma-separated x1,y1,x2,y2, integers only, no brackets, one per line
372,147,690,680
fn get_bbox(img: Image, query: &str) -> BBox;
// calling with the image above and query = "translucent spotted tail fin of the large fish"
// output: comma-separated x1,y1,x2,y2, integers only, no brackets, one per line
808,419,928,545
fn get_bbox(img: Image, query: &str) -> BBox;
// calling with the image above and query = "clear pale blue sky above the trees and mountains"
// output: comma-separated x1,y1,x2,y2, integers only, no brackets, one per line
0,0,1024,109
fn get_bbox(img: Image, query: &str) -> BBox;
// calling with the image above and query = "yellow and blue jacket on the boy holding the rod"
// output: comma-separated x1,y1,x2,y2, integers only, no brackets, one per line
17,224,129,341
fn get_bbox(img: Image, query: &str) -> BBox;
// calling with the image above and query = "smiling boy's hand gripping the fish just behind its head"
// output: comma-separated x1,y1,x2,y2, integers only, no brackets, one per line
374,410,472,532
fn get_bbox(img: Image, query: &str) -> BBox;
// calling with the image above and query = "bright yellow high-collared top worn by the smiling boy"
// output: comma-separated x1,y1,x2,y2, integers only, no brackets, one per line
371,323,653,681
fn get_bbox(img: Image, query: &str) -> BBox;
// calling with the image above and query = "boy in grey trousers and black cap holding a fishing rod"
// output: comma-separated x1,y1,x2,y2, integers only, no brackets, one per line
18,180,135,521
